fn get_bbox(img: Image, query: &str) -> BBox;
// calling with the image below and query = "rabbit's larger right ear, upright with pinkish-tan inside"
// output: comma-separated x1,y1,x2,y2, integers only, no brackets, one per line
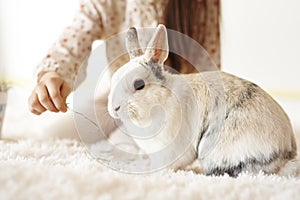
145,24,169,64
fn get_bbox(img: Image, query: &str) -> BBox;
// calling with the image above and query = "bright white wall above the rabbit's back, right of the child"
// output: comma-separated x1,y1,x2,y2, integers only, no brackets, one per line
222,0,300,92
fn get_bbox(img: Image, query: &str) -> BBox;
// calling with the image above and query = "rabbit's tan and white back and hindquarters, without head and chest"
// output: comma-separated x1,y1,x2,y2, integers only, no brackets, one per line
186,72,297,176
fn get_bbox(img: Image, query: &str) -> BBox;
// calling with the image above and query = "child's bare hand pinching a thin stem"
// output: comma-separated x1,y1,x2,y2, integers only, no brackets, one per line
28,72,71,115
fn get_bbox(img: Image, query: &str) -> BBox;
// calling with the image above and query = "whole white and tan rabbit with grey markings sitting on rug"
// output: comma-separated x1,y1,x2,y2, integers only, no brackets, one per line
108,24,299,177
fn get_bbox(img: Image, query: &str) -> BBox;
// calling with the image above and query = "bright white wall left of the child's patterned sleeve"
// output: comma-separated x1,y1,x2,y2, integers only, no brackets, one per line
0,0,79,85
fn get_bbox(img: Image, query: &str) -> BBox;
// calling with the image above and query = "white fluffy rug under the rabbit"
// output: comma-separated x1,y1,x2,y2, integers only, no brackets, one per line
0,140,300,200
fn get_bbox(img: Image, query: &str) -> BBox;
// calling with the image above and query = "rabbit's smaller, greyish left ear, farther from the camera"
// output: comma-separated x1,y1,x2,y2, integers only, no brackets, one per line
126,27,143,59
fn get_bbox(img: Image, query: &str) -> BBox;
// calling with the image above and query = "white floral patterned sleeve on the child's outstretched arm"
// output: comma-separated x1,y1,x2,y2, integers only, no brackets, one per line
38,0,104,86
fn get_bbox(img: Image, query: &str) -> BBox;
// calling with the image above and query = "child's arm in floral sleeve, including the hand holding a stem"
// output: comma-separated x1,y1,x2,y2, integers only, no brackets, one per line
29,0,108,114
